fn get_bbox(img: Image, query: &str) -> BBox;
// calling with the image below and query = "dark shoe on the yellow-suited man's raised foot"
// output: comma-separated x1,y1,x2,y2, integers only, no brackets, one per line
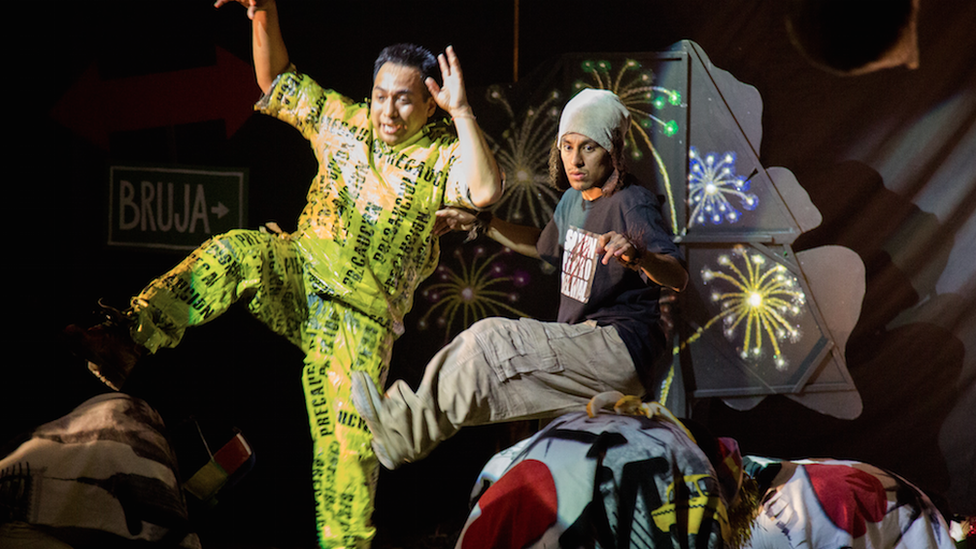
62,300,146,391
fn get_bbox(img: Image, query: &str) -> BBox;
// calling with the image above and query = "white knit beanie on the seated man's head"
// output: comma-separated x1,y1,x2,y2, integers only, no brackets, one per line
556,88,630,152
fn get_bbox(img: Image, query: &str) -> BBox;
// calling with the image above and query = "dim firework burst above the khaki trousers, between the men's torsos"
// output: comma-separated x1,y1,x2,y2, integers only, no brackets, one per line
417,246,529,343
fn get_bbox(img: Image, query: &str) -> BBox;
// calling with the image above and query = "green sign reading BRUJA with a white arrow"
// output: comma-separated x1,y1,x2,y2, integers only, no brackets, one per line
108,166,247,250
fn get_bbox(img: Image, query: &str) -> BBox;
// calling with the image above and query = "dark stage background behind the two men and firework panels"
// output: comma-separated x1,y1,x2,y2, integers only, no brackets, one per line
9,0,976,547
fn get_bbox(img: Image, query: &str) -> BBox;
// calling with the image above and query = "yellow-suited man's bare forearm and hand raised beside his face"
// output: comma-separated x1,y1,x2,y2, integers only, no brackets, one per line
426,46,503,208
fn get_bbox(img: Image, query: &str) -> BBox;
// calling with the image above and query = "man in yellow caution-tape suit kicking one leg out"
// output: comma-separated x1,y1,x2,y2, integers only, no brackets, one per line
66,0,502,547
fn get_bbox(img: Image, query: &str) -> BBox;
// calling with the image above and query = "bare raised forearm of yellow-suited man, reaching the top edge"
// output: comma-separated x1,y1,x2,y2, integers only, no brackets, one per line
214,0,289,93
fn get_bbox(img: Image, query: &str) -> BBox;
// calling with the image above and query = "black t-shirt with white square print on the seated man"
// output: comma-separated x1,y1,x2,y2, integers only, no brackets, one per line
536,177,682,374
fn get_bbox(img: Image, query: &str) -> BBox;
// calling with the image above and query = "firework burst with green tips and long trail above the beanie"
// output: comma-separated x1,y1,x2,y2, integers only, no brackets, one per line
573,59,681,233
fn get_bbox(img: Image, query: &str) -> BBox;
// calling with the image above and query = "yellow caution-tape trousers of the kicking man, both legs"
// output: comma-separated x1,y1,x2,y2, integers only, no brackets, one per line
132,230,393,548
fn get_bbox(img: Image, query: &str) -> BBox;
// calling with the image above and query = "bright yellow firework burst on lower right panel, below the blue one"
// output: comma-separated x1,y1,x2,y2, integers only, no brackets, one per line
701,246,806,370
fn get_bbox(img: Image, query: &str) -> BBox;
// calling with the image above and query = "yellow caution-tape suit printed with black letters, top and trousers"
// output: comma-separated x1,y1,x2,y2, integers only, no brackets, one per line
132,67,473,547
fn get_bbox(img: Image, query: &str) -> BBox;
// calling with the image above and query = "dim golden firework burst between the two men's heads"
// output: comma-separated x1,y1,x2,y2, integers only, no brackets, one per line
485,86,562,227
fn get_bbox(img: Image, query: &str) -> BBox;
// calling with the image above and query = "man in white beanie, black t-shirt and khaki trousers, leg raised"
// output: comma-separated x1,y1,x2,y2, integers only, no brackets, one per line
352,89,688,469
